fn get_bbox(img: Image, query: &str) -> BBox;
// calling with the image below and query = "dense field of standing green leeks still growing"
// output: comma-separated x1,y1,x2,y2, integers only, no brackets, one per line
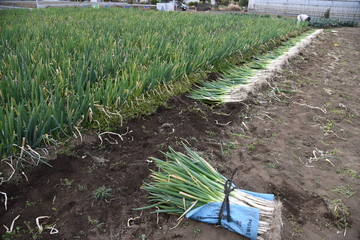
0,8,304,157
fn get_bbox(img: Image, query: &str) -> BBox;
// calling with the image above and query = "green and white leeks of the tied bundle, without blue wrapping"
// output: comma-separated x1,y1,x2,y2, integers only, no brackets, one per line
135,146,278,236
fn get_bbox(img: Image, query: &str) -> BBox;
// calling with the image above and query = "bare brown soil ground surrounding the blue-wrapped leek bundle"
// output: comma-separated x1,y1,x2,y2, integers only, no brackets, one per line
0,28,360,240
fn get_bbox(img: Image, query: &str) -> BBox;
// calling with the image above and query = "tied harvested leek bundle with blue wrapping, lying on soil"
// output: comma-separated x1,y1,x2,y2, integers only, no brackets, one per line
135,146,281,239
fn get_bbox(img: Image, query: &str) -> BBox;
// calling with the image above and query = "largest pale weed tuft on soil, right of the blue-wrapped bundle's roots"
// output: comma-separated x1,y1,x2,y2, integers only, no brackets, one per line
328,199,350,229
